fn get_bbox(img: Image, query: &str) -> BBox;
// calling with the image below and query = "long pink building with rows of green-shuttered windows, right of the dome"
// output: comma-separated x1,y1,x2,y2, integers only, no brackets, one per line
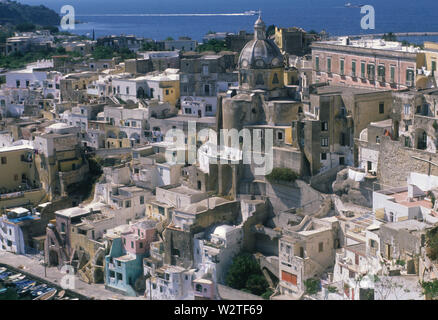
311,38,423,90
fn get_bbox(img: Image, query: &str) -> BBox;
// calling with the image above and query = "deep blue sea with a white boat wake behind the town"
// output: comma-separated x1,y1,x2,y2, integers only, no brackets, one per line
15,0,438,43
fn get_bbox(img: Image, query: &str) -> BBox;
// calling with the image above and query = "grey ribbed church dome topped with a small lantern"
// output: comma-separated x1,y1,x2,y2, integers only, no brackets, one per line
239,17,283,69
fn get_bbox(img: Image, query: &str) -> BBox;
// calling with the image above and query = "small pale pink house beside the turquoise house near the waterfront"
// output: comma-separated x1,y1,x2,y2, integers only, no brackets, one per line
122,220,157,254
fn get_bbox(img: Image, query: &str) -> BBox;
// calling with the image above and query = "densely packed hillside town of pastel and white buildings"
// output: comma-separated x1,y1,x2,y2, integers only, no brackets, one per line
0,15,438,300
